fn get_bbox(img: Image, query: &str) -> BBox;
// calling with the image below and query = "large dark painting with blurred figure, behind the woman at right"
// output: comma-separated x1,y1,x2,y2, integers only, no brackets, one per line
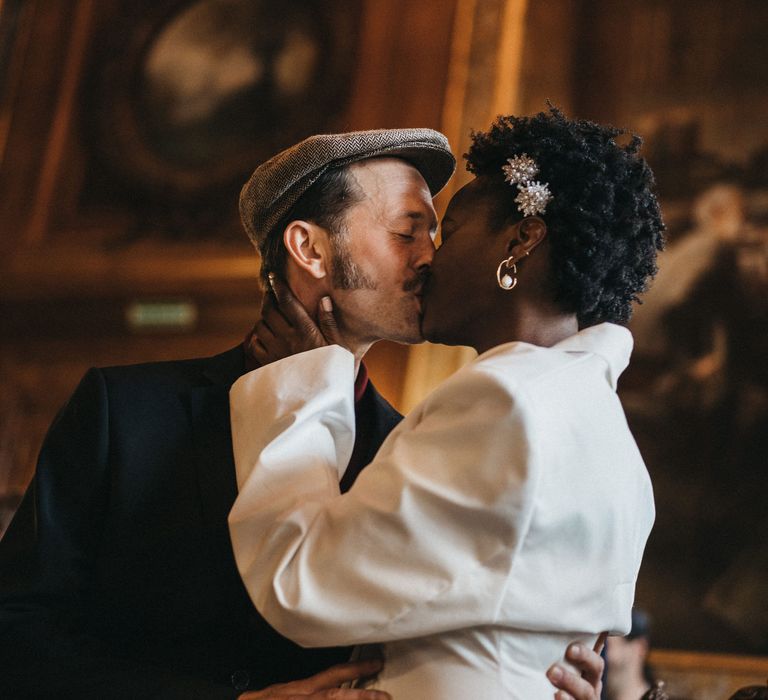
574,0,768,654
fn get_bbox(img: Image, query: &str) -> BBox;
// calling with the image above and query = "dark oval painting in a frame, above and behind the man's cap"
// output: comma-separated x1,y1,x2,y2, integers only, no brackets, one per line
82,0,361,236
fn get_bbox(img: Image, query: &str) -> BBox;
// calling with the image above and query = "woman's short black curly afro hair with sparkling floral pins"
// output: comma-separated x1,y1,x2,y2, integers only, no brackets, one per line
464,105,664,328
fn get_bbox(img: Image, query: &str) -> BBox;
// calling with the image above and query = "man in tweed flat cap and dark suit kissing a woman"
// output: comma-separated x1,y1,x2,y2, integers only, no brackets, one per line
0,129,599,700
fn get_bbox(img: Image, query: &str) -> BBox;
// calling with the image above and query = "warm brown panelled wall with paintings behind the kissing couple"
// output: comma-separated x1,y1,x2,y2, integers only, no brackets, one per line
0,0,768,698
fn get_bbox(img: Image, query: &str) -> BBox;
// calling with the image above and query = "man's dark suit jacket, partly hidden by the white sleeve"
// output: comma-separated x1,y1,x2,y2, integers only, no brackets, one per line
0,348,401,699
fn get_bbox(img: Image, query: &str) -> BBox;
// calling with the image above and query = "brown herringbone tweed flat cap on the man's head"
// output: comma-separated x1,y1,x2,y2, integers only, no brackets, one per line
240,129,456,247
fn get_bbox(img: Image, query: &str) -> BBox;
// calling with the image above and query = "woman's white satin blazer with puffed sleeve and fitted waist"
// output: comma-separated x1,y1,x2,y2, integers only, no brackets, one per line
229,324,654,700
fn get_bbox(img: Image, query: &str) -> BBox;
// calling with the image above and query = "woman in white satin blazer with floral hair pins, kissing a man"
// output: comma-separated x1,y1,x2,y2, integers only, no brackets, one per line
230,108,663,700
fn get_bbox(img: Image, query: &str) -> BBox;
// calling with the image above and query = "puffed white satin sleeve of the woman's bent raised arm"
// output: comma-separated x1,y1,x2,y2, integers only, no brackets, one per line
229,346,537,646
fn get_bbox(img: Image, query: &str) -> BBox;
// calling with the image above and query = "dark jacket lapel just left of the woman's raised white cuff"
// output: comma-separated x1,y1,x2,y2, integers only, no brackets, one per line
189,348,244,529
